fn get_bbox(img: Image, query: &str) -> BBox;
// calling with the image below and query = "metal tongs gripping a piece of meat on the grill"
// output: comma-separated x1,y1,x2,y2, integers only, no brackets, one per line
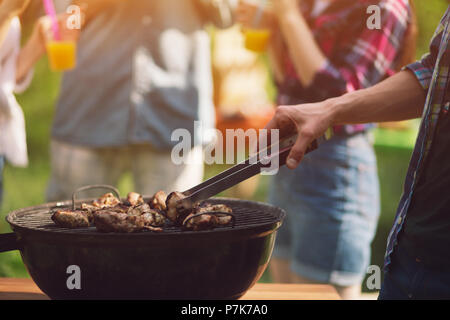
179,130,331,209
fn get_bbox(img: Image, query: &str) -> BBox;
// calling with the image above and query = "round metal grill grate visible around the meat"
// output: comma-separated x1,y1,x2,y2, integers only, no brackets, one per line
8,199,284,234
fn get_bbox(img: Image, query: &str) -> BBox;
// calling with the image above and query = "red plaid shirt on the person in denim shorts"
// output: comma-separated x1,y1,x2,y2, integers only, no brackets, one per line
278,0,411,134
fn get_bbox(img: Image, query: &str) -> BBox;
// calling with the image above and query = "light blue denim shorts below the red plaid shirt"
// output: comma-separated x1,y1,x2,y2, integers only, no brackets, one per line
269,133,380,286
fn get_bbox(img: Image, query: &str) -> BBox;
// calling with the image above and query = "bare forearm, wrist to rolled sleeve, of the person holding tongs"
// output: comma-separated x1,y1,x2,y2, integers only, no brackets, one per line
327,71,426,125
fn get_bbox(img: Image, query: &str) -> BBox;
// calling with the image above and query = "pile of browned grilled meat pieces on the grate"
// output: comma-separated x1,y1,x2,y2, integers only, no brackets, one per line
52,191,233,233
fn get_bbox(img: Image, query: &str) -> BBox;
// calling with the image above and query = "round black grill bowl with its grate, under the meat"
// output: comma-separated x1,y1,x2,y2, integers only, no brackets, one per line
0,198,285,299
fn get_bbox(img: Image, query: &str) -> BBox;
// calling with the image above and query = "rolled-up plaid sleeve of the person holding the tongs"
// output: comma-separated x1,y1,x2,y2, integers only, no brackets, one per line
403,11,450,91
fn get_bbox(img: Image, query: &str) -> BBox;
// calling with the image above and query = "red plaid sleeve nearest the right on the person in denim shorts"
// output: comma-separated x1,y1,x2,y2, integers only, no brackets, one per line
310,0,410,99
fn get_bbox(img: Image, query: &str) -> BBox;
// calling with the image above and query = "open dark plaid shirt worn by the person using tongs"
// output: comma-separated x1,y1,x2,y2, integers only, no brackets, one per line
385,6,450,269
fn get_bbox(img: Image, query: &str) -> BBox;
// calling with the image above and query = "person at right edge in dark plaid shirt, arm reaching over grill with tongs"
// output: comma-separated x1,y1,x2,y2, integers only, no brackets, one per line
266,1,450,300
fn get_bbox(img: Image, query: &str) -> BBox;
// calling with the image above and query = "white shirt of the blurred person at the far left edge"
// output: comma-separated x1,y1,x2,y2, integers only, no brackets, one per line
0,17,32,167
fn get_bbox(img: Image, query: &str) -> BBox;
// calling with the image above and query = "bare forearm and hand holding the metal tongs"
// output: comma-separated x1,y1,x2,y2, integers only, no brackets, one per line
266,71,426,169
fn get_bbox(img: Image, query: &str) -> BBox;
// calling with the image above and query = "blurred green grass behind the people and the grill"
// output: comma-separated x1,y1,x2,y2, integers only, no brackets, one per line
0,0,447,281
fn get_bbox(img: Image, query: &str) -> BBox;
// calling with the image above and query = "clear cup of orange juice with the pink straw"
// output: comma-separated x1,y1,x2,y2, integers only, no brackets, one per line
47,41,76,71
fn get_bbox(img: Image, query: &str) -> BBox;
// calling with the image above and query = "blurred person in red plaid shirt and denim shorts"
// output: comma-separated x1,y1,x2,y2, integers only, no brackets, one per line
237,0,414,299
